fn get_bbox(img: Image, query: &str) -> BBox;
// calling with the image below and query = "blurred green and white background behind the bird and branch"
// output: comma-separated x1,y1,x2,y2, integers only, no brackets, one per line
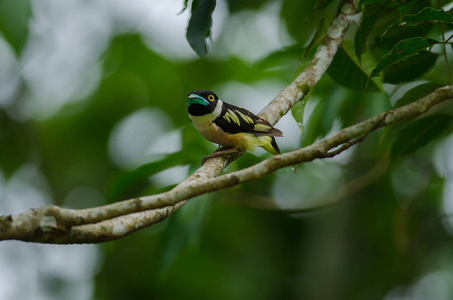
0,0,453,300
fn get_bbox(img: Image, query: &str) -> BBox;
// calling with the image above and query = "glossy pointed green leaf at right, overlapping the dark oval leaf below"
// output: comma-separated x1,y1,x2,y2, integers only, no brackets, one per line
370,37,440,78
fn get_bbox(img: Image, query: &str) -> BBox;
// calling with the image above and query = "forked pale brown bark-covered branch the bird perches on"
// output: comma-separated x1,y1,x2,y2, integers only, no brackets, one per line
6,1,453,244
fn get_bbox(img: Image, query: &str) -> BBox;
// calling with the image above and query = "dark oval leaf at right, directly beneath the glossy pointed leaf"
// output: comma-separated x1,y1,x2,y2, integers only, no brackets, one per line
382,50,438,84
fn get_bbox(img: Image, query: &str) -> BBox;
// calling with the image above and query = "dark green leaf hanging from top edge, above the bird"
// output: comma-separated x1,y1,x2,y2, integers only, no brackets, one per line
186,0,216,56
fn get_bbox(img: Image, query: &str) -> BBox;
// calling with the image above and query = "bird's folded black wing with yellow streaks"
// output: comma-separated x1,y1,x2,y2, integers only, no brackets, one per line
213,103,283,136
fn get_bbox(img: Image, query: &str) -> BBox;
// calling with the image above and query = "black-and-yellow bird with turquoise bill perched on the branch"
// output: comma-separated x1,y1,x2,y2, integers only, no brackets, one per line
187,90,294,170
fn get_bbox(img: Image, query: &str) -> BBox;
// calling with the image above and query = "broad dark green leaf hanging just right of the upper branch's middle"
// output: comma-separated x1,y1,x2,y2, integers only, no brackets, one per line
327,40,383,93
